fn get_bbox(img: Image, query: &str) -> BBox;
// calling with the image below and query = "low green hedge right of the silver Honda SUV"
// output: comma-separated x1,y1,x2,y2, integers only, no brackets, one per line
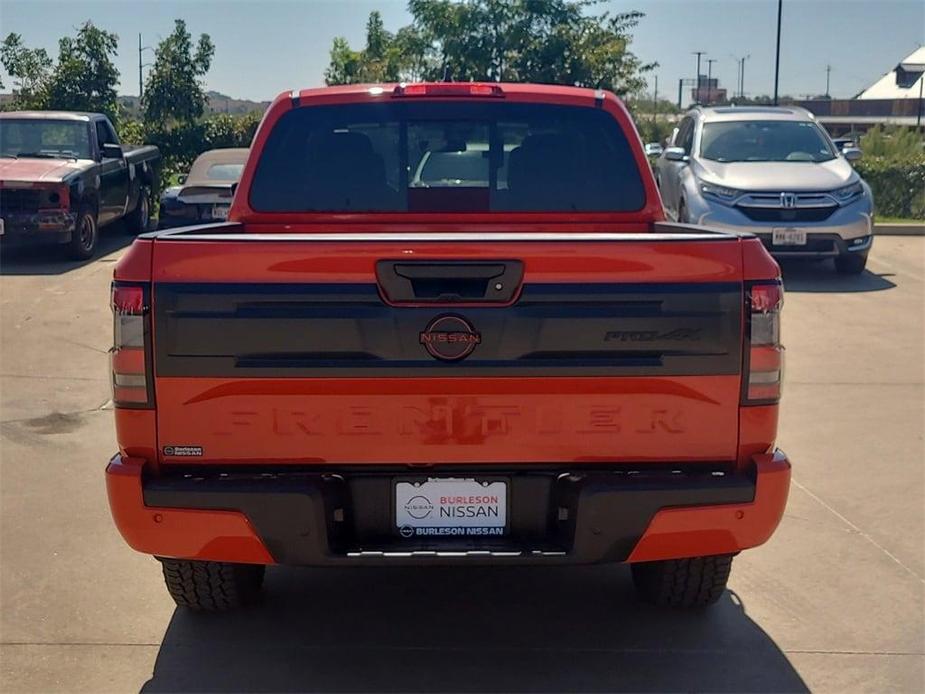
856,157,925,219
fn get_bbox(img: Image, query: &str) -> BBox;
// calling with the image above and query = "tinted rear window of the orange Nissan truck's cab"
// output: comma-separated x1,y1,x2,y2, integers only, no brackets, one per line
250,102,645,212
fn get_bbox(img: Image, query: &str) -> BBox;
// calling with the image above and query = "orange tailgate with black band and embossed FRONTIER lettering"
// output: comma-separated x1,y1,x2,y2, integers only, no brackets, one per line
152,231,743,464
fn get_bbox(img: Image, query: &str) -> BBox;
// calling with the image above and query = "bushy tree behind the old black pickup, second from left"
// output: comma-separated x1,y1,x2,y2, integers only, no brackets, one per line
45,21,119,121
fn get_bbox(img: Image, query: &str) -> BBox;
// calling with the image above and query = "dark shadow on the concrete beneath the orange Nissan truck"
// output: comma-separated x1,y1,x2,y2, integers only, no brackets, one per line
142,566,808,694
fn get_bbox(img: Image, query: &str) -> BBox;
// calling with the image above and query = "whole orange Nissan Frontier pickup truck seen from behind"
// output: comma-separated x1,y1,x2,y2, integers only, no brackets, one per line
106,83,790,610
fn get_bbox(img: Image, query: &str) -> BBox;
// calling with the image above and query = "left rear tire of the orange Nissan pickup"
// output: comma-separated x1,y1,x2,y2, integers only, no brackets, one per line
158,557,266,612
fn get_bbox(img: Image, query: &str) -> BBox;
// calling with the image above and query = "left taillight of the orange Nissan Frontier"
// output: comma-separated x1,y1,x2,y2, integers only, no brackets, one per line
109,282,154,408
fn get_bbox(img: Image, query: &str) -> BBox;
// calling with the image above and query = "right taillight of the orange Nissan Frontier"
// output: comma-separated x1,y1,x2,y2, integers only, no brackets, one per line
742,281,784,405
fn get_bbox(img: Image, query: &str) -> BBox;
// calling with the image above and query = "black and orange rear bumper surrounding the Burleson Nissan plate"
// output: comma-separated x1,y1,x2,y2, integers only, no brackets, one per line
106,451,790,565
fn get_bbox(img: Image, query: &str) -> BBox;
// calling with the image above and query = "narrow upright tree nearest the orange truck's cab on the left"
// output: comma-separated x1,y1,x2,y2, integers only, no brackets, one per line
144,19,215,128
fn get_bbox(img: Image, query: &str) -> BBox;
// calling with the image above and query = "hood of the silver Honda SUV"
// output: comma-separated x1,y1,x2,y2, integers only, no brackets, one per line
694,157,858,191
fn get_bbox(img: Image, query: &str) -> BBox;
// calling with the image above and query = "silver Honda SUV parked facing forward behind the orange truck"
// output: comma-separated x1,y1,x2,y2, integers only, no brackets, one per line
655,106,873,274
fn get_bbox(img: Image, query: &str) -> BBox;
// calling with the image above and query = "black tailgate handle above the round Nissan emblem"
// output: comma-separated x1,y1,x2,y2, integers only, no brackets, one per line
376,260,524,304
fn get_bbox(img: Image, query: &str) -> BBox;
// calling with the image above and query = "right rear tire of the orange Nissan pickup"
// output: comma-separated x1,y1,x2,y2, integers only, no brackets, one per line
631,554,732,607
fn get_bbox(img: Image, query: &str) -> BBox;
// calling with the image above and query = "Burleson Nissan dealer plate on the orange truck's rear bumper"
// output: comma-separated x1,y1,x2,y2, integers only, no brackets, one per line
395,477,507,539
